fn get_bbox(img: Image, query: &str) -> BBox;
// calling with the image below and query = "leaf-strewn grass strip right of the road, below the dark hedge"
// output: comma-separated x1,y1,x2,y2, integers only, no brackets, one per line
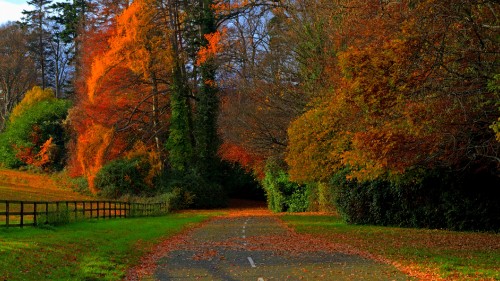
281,215,500,280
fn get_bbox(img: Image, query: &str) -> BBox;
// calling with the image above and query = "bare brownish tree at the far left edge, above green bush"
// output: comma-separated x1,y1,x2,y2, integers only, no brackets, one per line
0,23,36,131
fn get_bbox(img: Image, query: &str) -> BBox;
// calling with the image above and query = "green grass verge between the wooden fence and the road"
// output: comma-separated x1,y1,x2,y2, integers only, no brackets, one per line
0,213,219,280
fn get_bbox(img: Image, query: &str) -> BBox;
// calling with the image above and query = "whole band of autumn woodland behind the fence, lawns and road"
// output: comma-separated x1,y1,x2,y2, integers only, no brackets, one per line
0,0,500,231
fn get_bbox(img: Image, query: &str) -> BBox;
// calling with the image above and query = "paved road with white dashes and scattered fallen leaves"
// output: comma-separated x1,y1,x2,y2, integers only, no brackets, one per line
155,216,411,281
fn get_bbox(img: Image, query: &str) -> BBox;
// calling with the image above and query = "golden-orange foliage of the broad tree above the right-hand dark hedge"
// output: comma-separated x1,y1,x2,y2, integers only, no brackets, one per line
287,0,498,181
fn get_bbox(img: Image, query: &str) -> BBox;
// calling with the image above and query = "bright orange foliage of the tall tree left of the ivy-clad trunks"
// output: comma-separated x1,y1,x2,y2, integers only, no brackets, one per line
69,0,171,193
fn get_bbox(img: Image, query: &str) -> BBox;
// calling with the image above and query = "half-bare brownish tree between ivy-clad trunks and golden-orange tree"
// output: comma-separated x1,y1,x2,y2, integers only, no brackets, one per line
219,0,341,171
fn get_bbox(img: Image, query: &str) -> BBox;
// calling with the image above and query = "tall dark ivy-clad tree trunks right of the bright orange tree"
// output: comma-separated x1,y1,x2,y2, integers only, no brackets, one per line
166,0,225,207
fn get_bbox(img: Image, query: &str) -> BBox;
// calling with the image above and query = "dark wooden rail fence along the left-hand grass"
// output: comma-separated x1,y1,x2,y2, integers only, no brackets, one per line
0,200,169,227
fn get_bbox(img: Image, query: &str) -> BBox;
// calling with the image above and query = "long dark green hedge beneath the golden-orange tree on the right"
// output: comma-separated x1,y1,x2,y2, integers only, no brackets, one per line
331,165,500,231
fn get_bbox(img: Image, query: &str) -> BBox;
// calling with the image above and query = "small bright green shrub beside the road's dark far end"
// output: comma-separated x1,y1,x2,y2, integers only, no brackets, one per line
262,160,309,212
